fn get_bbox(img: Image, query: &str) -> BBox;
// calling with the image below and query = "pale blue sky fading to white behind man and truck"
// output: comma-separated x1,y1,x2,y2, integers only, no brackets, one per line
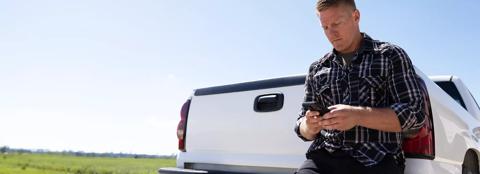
0,0,480,154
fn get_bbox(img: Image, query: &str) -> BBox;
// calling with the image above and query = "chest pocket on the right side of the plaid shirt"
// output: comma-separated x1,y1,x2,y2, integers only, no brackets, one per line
359,75,386,107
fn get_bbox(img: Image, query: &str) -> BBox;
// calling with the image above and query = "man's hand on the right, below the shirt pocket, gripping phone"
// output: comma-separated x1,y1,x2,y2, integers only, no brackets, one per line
319,104,362,131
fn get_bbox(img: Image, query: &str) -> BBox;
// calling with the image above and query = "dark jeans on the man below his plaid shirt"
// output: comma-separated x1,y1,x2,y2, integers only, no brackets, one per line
295,149,405,174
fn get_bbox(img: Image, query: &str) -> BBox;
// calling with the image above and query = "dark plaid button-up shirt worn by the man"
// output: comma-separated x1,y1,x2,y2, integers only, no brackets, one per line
295,33,425,166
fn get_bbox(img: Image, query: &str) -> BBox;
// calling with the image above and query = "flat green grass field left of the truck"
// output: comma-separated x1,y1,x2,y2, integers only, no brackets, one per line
0,154,175,174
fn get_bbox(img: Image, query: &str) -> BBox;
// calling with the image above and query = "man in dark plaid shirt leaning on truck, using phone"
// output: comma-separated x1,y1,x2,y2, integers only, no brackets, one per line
295,0,425,174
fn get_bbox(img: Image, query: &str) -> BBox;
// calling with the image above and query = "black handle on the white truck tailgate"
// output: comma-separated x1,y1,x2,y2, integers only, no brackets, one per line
253,93,284,112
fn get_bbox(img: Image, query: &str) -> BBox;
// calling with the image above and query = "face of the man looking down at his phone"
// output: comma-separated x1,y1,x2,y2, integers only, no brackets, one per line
317,4,360,53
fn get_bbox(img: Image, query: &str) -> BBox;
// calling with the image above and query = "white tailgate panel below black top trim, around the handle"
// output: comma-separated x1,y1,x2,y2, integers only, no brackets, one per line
185,85,309,168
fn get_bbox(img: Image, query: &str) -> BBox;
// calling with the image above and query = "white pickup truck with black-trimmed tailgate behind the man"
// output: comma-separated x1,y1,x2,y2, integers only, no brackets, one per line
159,69,480,174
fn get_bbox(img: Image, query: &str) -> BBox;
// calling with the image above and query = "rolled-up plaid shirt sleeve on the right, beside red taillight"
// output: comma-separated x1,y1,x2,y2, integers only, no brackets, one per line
388,46,425,132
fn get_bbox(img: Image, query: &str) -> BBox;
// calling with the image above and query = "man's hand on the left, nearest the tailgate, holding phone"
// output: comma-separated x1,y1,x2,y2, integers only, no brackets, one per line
300,110,322,140
